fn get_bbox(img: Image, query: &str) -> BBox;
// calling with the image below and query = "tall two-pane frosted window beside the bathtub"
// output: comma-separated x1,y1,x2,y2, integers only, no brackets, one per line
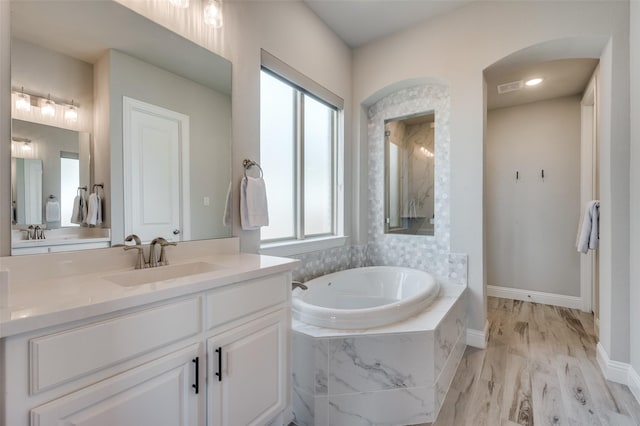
260,52,342,242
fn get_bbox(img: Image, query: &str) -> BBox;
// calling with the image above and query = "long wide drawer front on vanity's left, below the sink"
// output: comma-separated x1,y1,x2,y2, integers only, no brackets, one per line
29,297,202,394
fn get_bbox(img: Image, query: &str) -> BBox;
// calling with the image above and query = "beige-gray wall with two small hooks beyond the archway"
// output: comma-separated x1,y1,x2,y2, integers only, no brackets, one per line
485,97,580,296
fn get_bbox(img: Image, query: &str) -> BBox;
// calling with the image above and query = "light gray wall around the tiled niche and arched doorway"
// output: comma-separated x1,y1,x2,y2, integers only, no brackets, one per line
353,1,629,362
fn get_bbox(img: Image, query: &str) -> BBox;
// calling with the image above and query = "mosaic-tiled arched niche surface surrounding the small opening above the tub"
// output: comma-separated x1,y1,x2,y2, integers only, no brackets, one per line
367,84,450,278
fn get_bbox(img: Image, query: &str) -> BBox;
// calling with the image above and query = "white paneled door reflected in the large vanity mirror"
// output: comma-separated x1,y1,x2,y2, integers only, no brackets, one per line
123,97,189,241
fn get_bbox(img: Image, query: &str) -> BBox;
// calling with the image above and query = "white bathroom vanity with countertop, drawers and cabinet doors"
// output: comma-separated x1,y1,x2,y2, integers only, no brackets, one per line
0,238,298,426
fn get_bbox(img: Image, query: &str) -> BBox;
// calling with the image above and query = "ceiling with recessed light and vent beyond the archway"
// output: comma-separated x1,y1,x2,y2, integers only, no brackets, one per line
485,59,598,110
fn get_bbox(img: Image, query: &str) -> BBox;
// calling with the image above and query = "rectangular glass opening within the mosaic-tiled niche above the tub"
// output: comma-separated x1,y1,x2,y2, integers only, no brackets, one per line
384,111,435,235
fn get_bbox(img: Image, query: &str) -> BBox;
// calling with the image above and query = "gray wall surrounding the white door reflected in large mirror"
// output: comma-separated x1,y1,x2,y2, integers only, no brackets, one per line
108,50,231,243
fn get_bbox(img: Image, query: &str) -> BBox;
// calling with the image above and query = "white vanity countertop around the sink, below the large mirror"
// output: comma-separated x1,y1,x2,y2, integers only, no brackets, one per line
0,243,299,338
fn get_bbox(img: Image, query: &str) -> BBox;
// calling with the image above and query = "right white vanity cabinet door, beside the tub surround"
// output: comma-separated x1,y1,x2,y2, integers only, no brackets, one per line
207,310,288,426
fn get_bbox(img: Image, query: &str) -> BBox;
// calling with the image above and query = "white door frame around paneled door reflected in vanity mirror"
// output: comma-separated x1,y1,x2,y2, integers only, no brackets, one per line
122,96,191,241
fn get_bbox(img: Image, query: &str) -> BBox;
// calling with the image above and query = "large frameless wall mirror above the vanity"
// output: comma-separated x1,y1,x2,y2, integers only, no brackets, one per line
11,0,232,254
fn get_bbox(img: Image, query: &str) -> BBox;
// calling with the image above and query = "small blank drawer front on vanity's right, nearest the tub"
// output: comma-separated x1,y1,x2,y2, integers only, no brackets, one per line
205,275,289,330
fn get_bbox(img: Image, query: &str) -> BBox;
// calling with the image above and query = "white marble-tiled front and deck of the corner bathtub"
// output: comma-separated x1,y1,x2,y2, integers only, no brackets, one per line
292,286,466,426
